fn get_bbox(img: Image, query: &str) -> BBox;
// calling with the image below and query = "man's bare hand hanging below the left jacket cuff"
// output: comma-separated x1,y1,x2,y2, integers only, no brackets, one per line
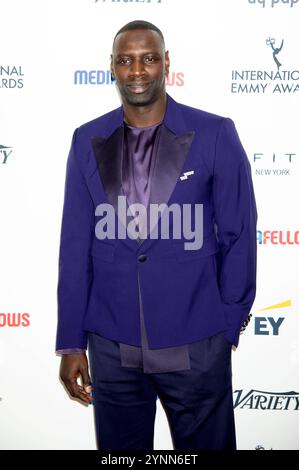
59,352,93,404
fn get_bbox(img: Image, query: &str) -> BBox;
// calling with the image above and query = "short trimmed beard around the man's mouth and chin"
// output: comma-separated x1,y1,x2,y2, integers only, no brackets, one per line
116,76,165,106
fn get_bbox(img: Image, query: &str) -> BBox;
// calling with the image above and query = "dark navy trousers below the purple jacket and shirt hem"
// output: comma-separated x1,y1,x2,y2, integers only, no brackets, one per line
88,333,236,450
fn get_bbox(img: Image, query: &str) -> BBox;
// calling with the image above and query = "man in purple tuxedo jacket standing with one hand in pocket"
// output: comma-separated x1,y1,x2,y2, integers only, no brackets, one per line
56,21,257,450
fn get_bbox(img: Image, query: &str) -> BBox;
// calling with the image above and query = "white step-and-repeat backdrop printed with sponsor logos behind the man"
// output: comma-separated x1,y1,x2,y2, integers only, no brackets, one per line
0,0,299,450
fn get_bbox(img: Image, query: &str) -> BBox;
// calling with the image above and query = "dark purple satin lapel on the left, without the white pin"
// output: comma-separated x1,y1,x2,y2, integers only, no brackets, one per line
92,126,124,213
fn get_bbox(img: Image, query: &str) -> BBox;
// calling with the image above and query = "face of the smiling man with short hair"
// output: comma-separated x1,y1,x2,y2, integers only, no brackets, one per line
111,29,169,106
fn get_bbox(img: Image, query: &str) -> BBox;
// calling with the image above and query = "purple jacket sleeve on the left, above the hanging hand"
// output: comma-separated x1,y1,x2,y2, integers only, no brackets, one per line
56,130,94,351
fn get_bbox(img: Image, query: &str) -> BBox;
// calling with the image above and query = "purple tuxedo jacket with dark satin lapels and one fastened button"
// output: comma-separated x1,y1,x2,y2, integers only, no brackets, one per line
56,94,257,350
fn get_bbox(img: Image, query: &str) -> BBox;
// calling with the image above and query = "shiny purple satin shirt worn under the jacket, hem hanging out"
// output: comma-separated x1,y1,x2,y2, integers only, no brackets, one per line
56,123,190,373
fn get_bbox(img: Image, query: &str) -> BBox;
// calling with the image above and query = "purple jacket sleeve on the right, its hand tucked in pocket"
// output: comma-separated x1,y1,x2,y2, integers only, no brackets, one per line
213,118,257,346
